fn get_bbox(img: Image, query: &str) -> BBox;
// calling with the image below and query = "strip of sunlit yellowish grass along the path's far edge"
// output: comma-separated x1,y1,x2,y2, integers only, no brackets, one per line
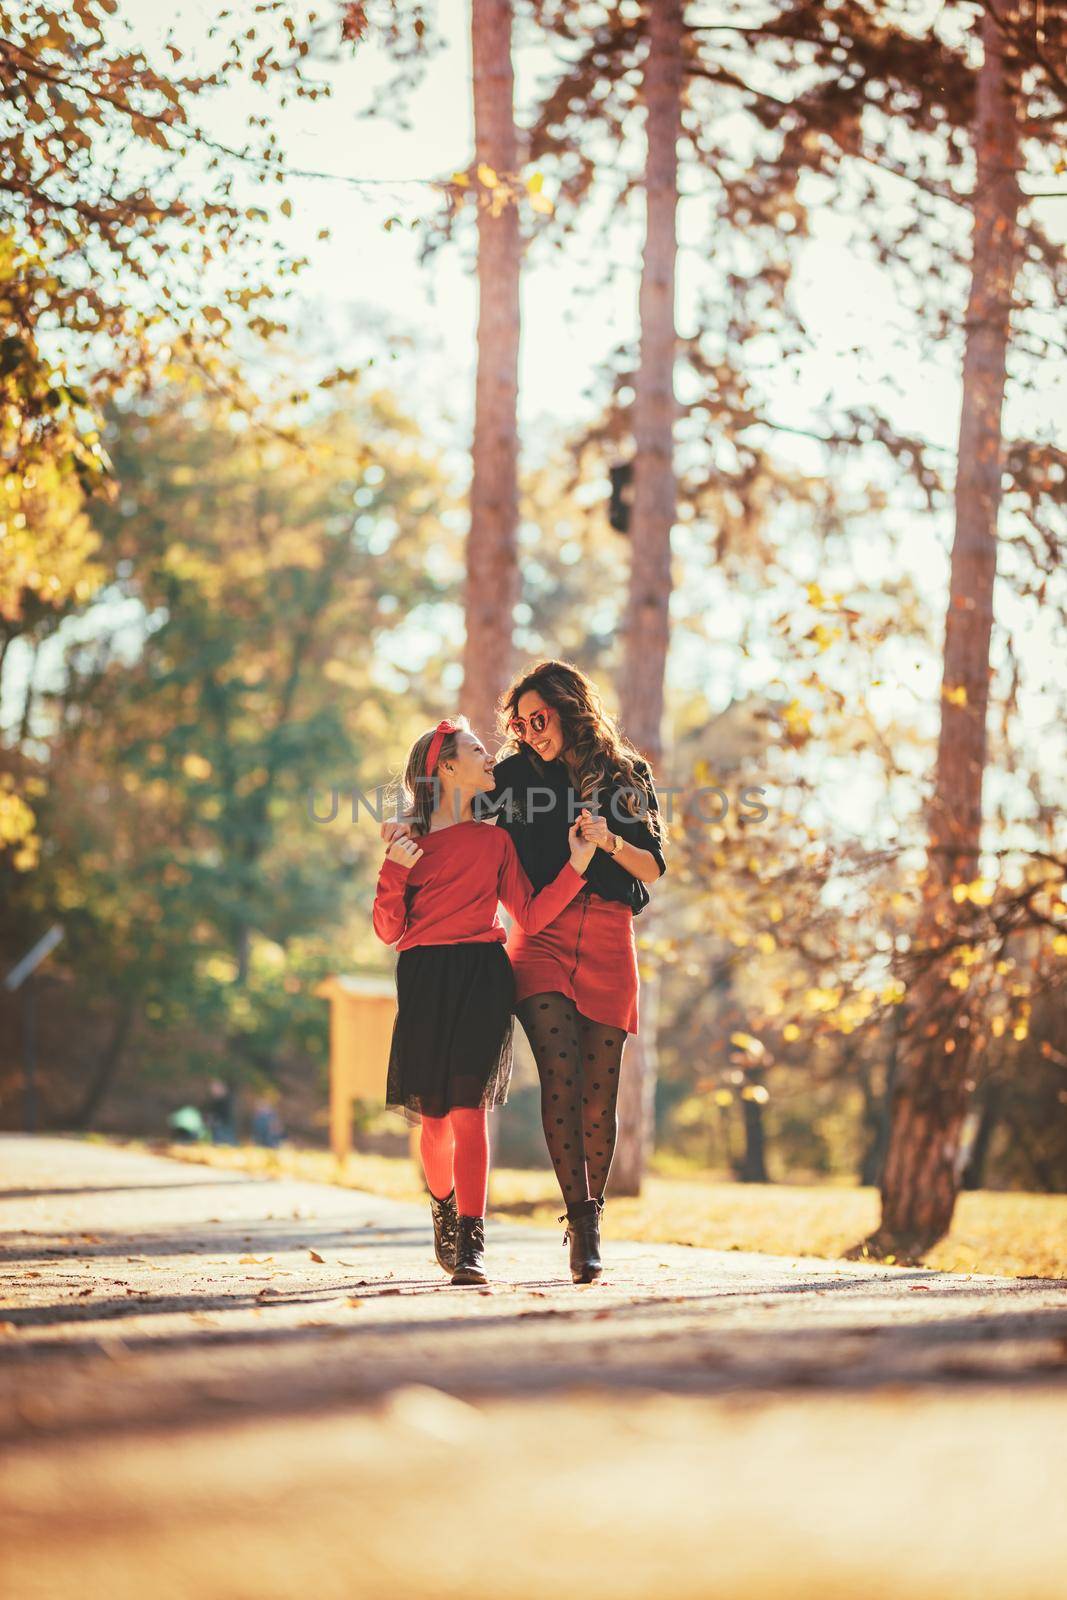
135,1144,1067,1278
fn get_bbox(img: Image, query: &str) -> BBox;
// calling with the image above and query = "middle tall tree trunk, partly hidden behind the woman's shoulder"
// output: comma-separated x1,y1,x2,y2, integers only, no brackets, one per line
611,0,683,1195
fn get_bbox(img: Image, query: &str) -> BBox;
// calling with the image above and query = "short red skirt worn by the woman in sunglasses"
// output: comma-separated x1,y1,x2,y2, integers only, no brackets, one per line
507,888,637,1034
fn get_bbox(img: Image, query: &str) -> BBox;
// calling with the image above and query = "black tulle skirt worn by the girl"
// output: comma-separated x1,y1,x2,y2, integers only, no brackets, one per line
386,941,515,1122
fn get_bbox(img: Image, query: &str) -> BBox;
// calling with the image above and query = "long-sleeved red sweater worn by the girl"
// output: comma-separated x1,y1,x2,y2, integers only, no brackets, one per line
373,822,585,950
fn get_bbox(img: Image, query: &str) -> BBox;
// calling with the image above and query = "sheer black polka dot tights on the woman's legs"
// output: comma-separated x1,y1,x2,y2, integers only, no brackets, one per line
515,992,625,1205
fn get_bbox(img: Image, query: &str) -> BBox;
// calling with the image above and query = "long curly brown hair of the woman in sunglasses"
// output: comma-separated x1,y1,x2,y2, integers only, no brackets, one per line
498,661,664,840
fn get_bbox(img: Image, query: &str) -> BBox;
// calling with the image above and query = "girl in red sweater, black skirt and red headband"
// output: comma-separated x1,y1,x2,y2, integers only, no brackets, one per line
373,717,595,1283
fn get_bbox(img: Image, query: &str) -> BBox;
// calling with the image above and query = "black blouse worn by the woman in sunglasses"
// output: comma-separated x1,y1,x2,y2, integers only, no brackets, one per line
475,746,667,915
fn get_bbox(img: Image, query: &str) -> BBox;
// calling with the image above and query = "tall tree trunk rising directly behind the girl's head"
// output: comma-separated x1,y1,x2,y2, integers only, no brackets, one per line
462,0,522,749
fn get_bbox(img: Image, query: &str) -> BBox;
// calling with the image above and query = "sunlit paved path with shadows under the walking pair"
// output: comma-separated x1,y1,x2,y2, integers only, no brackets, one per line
0,1138,1067,1600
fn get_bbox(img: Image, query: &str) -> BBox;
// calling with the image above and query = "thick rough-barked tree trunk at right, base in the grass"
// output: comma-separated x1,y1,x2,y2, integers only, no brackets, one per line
870,10,1019,1254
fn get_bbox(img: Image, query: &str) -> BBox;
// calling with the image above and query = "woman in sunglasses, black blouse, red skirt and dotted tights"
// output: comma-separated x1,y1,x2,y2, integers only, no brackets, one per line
382,661,667,1283
